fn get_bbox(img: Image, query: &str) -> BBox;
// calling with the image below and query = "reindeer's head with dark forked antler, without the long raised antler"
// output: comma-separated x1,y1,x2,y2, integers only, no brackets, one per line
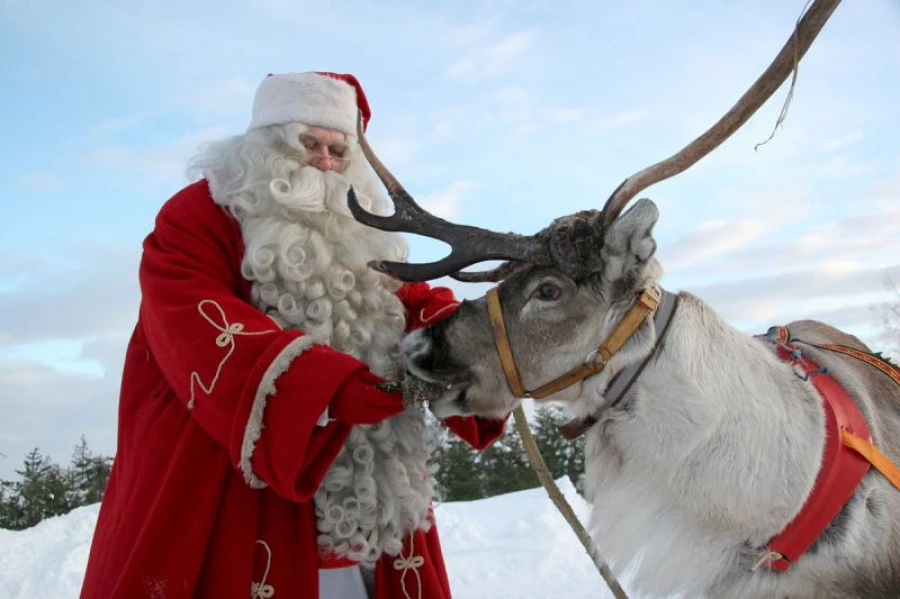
348,116,661,418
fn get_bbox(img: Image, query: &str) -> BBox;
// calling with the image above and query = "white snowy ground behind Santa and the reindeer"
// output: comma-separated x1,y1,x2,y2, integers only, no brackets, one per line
0,479,640,599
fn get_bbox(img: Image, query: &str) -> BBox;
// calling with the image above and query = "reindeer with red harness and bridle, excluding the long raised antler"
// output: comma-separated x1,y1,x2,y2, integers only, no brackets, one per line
348,2,900,599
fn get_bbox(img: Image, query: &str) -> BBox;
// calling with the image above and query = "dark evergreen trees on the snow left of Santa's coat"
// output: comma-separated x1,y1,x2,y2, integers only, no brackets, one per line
0,435,113,530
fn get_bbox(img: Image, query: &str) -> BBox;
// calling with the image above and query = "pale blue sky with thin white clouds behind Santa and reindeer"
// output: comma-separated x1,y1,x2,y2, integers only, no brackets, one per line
0,0,900,479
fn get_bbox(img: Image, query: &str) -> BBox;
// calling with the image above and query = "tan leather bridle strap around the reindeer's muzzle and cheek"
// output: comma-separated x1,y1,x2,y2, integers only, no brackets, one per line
486,287,660,399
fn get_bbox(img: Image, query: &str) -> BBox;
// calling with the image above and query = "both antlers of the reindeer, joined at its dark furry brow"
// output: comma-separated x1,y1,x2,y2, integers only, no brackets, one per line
347,0,840,282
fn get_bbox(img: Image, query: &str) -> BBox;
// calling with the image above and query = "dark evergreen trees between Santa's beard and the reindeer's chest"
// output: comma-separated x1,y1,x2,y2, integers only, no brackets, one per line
434,406,584,501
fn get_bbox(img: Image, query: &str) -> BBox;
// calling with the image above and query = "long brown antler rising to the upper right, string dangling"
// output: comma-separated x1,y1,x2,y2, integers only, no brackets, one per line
602,0,841,226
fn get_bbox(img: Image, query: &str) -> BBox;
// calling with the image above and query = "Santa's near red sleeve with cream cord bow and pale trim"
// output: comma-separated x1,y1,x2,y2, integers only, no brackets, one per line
139,191,367,501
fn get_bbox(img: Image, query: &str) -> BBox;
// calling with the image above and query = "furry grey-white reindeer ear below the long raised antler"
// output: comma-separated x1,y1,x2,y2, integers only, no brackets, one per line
602,198,659,296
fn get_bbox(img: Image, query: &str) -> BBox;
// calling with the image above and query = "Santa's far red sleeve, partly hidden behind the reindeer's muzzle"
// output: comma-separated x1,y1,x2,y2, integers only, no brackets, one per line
398,283,509,450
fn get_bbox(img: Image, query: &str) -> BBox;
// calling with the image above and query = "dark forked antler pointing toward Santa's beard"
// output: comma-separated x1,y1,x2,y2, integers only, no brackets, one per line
347,119,551,281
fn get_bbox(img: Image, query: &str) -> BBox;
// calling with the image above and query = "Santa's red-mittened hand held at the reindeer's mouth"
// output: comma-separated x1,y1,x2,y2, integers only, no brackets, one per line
328,370,406,424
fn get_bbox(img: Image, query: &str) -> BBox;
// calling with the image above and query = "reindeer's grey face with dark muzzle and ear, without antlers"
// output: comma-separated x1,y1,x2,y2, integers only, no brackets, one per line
403,200,661,418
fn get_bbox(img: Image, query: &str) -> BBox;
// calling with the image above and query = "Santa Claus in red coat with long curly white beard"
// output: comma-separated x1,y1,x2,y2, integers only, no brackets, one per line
81,73,503,599
